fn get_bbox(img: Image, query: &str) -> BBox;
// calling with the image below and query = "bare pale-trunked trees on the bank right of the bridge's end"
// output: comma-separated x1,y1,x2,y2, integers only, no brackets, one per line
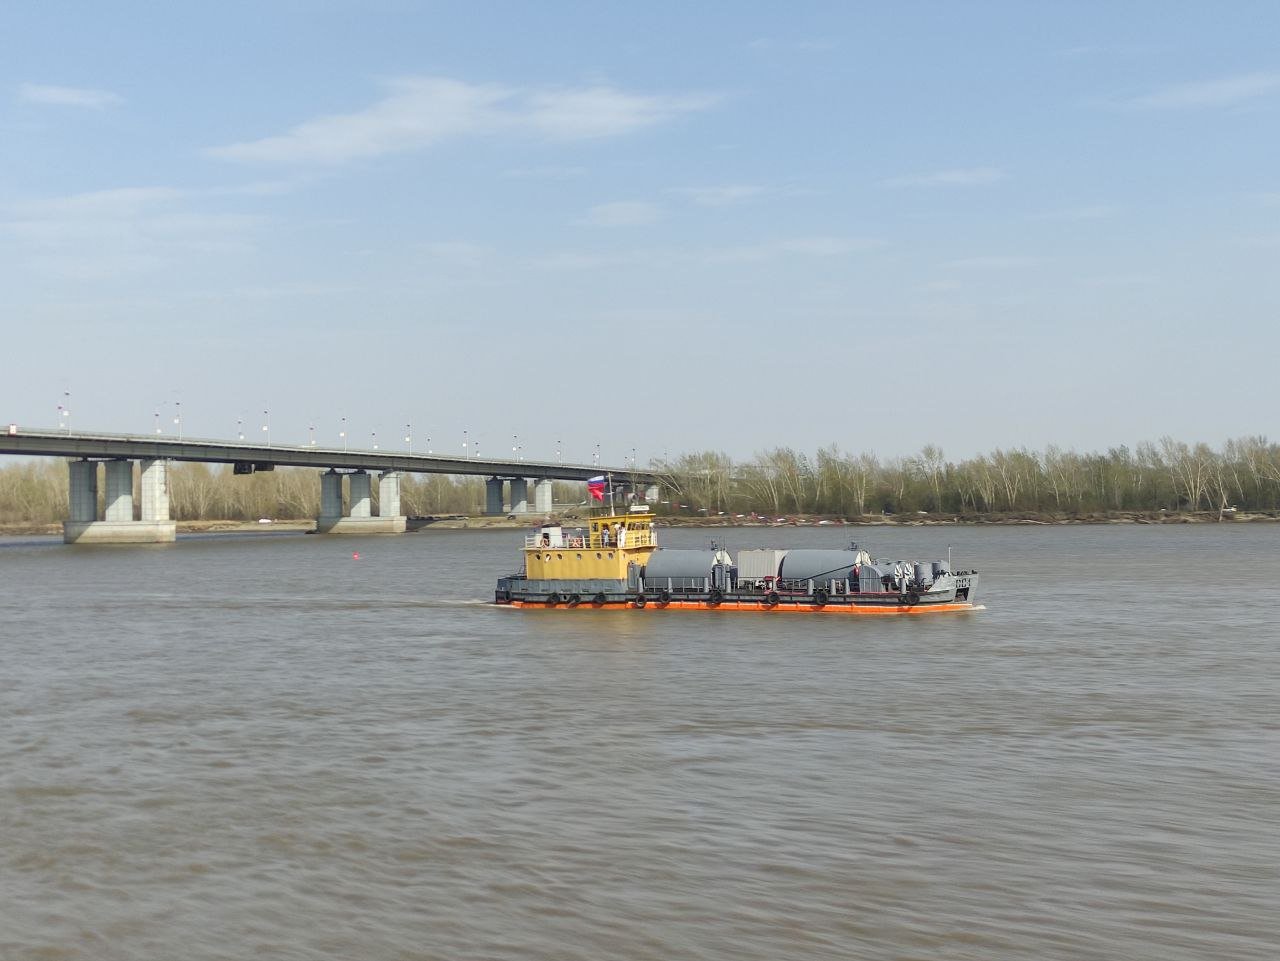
660,436,1280,518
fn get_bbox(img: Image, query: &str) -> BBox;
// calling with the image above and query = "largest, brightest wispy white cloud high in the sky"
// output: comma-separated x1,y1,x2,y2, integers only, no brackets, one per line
210,77,716,164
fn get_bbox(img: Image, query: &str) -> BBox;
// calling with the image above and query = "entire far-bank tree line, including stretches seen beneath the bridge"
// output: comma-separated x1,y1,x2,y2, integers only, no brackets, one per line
0,436,1280,523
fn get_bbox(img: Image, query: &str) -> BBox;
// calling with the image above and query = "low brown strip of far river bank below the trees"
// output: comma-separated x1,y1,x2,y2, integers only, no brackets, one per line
0,511,1280,537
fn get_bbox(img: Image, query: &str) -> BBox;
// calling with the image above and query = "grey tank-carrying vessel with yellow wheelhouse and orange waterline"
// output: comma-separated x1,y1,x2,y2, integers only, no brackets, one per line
494,507,978,614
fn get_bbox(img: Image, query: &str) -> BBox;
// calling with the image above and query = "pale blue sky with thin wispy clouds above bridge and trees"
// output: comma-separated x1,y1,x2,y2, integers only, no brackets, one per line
0,0,1280,465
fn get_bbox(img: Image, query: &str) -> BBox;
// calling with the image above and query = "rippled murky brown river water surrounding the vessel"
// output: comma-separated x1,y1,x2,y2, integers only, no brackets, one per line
0,525,1280,961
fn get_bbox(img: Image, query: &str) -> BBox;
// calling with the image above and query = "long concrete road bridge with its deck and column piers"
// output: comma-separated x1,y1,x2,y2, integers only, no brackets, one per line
0,425,658,544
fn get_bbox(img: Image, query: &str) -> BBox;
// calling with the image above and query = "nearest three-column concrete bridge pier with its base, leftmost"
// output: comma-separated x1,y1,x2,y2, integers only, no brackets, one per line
63,461,178,544
